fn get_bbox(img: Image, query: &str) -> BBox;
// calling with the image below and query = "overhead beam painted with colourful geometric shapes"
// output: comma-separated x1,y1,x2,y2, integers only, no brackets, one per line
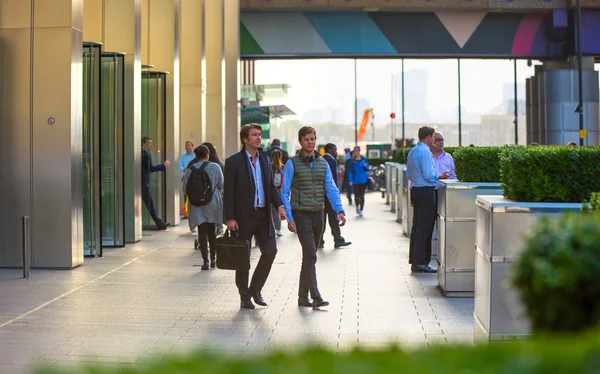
240,10,600,58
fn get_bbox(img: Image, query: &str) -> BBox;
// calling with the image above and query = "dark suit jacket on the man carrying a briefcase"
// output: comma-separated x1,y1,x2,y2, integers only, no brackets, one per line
224,148,283,238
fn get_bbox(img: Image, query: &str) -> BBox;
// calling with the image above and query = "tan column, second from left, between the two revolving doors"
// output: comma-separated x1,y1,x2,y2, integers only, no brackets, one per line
83,0,142,243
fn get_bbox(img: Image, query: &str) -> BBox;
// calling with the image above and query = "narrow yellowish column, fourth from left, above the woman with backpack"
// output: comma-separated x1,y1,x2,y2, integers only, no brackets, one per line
177,0,204,156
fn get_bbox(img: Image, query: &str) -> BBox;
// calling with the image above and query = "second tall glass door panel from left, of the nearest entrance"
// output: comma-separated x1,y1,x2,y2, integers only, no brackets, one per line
100,52,125,247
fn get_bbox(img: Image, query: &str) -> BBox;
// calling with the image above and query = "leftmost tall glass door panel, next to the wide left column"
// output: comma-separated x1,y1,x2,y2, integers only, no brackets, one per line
82,43,102,257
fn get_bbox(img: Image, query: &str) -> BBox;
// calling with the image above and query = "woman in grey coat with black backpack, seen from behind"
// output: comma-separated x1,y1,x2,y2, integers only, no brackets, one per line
182,145,223,270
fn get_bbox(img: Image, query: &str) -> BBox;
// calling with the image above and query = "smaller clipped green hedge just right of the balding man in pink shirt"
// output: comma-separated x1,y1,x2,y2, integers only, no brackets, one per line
452,147,502,183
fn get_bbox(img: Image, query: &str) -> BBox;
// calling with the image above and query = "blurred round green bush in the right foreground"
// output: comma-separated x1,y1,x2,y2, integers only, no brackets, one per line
513,214,600,332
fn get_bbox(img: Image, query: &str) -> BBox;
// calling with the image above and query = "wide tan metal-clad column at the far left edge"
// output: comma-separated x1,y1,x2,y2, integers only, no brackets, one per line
0,0,83,269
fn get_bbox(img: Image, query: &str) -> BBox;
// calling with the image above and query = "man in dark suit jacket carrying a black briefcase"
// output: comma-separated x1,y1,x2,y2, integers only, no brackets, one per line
224,123,287,309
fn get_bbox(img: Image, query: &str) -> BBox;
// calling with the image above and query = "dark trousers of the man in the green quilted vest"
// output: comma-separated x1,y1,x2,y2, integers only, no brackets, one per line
292,210,324,299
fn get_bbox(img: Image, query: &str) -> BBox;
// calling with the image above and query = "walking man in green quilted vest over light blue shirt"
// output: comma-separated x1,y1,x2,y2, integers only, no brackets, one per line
281,126,346,308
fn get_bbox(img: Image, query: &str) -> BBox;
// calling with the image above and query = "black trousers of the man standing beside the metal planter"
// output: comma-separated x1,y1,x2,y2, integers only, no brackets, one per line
408,187,437,265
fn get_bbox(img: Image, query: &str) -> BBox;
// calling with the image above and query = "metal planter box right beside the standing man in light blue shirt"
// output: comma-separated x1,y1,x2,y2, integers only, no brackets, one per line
437,180,502,297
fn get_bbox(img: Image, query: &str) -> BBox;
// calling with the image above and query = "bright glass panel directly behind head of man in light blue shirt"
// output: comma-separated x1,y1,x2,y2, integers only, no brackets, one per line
398,59,460,147
